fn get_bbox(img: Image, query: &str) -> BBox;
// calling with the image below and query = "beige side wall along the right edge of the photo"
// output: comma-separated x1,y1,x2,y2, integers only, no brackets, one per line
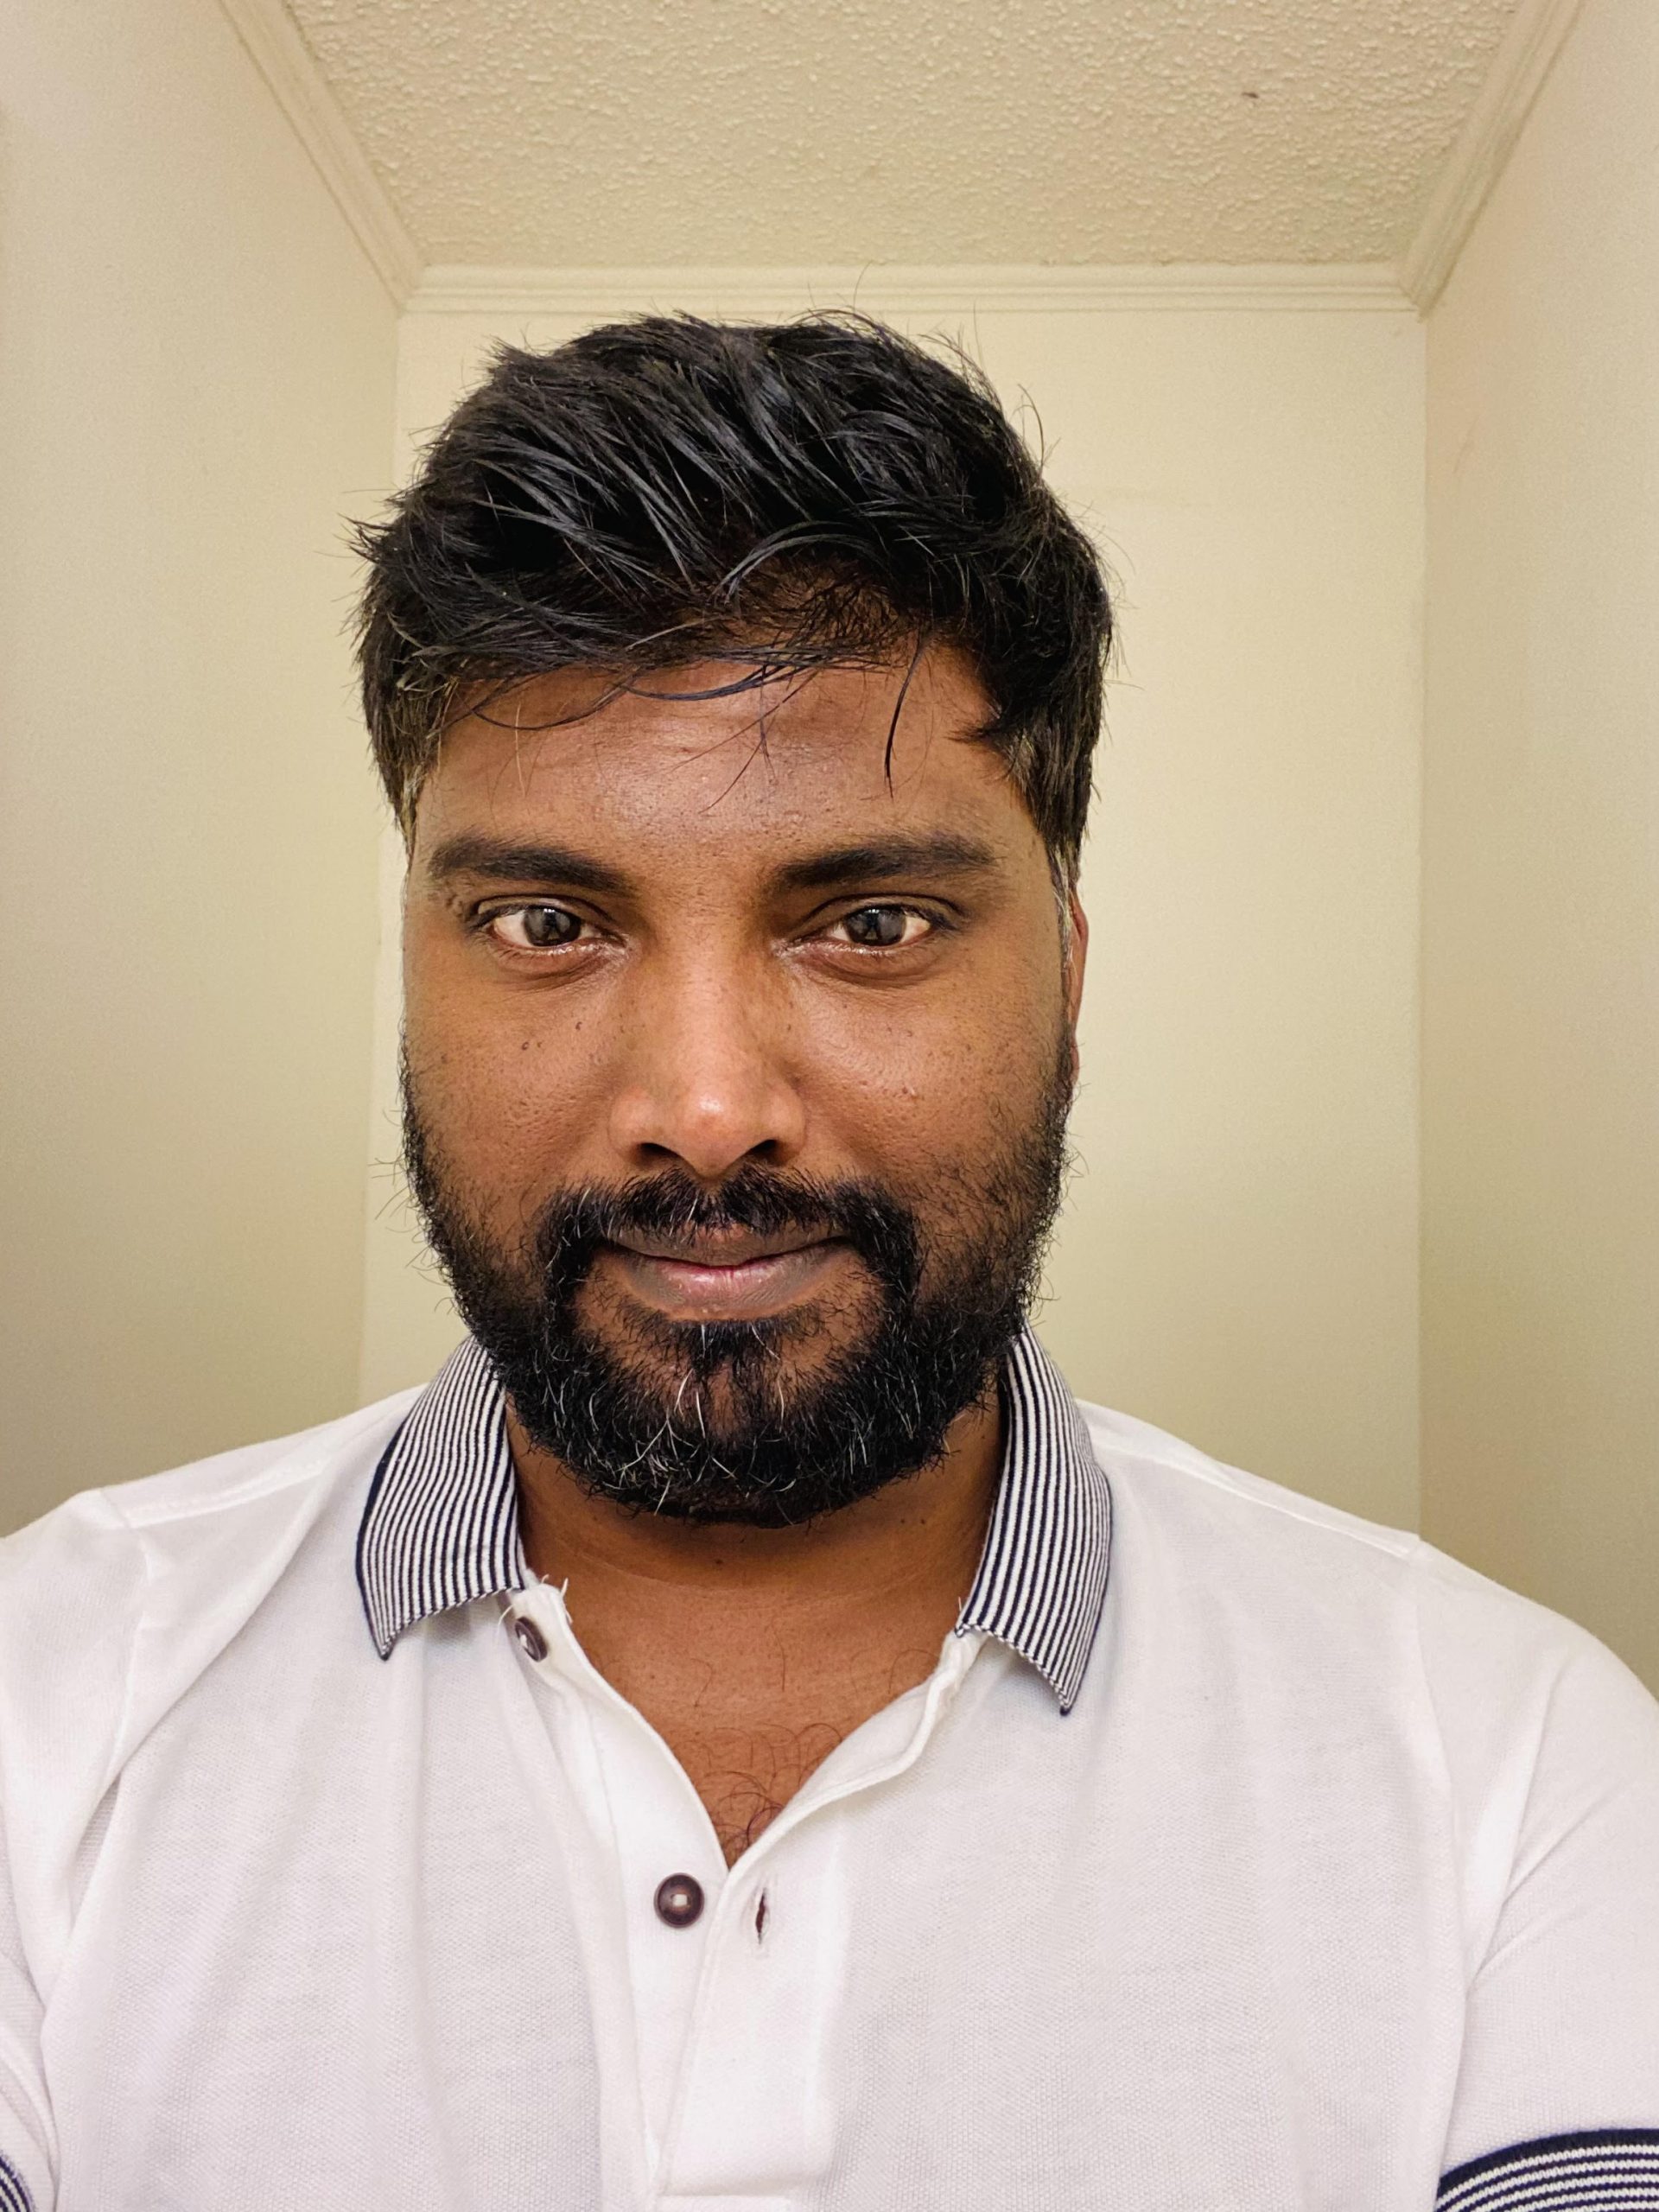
1422,0,1659,1688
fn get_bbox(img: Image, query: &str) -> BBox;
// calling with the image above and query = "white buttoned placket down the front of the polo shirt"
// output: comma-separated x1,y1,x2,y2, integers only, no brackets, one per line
499,1584,982,2212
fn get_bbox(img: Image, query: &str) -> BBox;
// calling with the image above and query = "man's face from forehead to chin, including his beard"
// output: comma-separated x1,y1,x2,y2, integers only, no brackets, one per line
404,651,1082,1522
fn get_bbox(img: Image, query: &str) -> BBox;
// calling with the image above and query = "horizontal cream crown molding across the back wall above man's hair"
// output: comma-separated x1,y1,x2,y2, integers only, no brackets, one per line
407,261,1411,321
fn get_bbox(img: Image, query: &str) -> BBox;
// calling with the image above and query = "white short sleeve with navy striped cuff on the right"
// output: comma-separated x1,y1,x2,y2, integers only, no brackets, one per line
1438,1608,1659,2212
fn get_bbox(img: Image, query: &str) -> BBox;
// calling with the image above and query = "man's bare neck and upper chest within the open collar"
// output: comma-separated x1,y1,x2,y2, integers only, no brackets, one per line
509,1387,1002,1858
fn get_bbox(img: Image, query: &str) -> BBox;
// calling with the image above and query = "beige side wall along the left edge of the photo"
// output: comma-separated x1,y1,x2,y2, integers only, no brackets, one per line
0,0,396,1529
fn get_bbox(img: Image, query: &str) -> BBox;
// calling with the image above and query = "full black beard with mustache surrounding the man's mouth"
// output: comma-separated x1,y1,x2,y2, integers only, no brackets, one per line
403,1038,1071,1526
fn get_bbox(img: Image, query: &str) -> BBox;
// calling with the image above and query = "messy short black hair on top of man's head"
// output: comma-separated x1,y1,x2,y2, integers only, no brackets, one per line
359,315,1113,880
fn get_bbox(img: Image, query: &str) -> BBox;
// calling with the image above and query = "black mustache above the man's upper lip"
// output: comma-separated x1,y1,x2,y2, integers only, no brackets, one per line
533,1164,923,1294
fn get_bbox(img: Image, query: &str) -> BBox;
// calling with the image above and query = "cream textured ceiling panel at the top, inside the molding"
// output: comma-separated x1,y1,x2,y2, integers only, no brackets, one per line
289,0,1516,268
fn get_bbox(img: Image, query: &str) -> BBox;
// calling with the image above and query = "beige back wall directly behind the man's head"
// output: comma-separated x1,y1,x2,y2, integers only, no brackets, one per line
363,294,1422,1524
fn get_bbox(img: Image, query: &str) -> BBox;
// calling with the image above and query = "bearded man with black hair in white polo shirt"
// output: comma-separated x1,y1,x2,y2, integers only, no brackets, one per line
0,321,1659,2212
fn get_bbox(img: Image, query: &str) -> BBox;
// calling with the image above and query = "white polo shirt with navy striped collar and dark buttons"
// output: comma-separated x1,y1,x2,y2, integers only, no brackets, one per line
0,1338,1659,2212
